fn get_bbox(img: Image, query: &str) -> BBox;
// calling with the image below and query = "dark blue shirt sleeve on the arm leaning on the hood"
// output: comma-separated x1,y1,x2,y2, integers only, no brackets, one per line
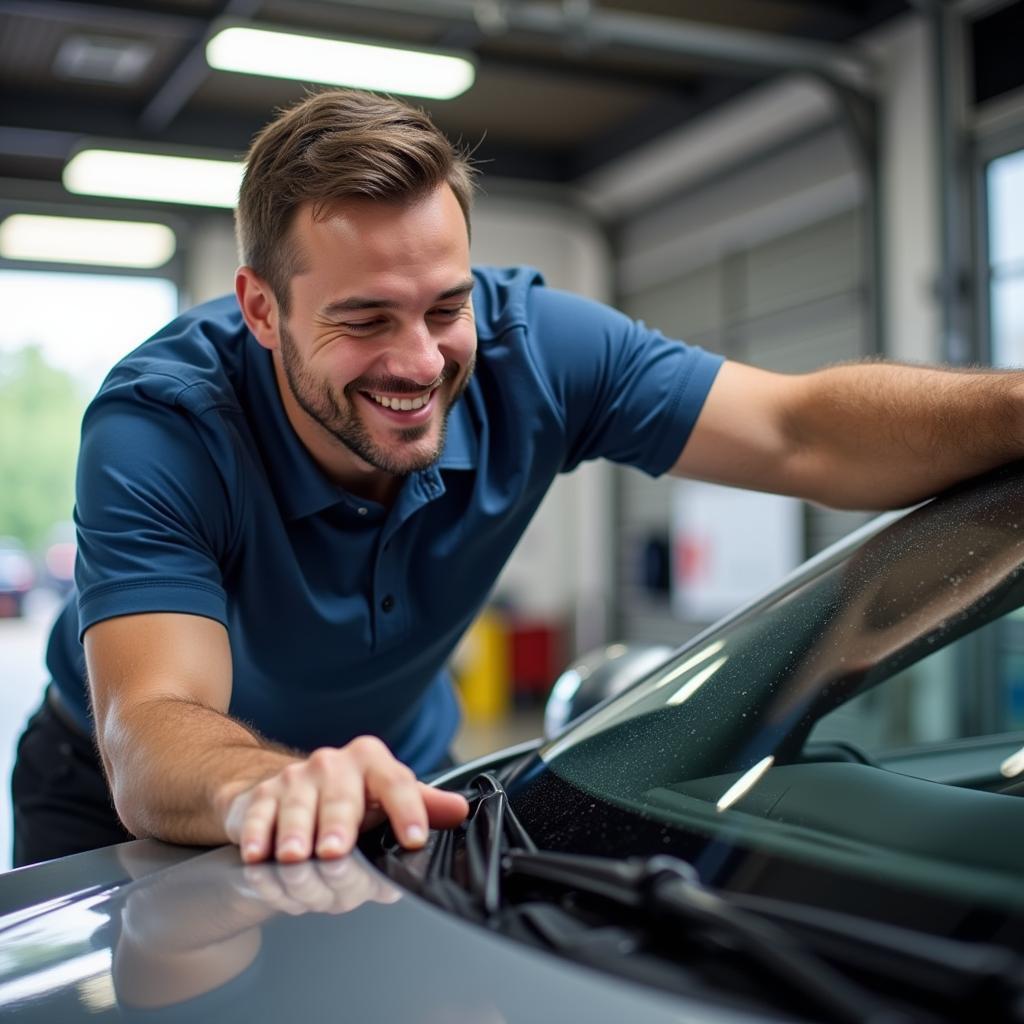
75,398,232,638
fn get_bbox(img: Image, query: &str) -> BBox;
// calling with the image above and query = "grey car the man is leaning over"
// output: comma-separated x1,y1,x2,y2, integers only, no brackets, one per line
0,465,1024,1024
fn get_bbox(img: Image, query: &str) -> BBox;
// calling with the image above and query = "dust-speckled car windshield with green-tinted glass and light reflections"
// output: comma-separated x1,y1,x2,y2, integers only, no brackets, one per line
540,466,1024,908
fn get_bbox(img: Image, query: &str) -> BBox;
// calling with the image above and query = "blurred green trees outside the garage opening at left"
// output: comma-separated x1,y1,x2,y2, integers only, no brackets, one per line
0,345,85,550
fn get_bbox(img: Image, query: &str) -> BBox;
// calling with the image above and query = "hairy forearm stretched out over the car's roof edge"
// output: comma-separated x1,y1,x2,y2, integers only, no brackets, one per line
785,364,1024,508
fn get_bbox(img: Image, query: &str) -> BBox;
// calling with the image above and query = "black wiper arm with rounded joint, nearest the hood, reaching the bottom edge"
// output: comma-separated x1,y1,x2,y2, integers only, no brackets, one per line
503,850,910,1024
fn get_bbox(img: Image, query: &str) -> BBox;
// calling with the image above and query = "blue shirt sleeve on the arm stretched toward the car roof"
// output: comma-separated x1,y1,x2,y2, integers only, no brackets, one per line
527,287,724,476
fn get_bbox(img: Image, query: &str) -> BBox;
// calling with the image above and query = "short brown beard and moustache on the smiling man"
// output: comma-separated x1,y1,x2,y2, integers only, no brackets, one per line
280,324,473,476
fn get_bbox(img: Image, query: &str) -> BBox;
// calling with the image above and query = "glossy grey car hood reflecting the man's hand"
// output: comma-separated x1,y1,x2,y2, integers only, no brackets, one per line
0,841,764,1024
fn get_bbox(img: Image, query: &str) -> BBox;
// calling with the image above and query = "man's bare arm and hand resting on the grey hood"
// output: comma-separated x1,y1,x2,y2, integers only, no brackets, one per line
84,612,469,862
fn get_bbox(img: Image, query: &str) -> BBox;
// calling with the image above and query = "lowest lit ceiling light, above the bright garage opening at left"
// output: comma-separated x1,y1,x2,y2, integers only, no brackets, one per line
0,213,176,269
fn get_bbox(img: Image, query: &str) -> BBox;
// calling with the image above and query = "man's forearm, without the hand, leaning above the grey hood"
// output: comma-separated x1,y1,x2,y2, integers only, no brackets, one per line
100,697,301,846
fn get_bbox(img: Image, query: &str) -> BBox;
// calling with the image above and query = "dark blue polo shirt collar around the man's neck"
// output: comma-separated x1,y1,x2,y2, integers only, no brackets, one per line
247,338,479,519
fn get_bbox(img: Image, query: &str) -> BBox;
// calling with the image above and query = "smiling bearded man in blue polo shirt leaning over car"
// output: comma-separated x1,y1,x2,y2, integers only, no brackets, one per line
12,92,1024,864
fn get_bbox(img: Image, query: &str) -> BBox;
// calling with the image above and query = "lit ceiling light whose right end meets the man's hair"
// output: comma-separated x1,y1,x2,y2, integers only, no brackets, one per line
63,150,243,207
